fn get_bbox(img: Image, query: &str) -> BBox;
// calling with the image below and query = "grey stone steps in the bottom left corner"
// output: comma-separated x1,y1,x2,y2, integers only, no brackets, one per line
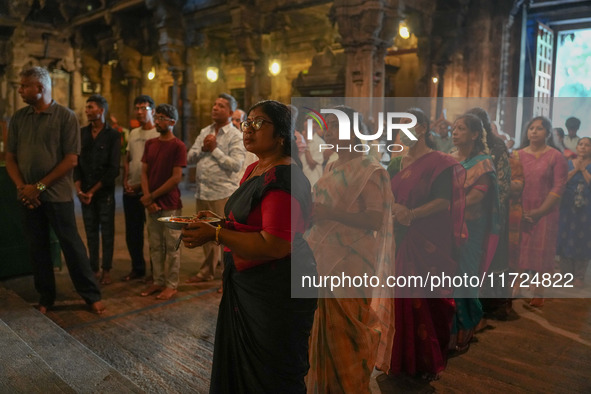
0,285,143,393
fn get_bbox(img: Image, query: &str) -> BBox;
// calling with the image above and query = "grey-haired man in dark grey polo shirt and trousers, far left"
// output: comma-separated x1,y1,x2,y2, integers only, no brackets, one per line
6,67,105,314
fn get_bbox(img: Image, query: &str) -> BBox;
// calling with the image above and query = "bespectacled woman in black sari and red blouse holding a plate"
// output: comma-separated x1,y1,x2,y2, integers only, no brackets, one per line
183,101,316,393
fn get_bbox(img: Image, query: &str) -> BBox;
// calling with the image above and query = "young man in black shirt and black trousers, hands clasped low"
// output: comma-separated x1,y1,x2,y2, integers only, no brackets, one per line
74,94,121,285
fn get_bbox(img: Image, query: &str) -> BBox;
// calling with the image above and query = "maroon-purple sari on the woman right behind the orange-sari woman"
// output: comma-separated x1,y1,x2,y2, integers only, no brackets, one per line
389,151,466,377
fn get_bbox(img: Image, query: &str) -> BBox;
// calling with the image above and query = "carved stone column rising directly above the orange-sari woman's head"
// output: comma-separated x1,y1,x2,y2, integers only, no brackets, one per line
332,0,400,120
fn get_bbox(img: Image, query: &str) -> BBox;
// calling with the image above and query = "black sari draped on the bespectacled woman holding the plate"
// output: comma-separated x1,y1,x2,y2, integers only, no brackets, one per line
210,166,317,393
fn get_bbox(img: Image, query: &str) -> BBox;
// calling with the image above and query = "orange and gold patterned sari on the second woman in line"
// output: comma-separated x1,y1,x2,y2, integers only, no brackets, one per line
306,156,394,393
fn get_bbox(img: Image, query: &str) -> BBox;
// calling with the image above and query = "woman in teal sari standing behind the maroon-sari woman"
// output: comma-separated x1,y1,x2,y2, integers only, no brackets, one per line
450,114,499,354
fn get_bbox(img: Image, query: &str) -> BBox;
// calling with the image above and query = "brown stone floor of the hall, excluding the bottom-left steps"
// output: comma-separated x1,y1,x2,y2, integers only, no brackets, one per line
0,186,591,393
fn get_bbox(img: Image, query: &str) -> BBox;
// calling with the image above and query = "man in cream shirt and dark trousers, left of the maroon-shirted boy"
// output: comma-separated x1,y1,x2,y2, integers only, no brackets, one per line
123,95,160,281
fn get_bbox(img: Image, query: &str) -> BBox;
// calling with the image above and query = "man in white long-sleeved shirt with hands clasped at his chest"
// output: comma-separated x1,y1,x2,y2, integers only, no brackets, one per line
187,93,246,283
